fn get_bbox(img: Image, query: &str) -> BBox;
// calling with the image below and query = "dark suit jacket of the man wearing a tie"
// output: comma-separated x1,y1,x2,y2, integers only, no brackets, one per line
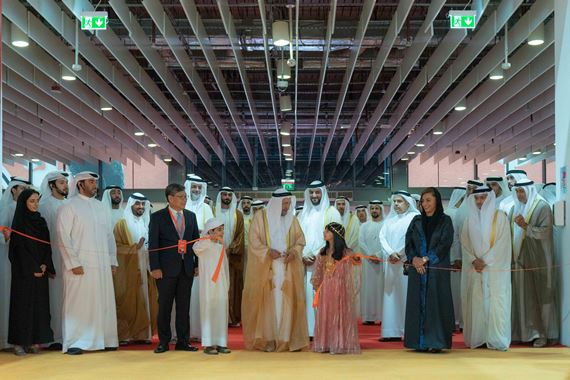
148,206,200,277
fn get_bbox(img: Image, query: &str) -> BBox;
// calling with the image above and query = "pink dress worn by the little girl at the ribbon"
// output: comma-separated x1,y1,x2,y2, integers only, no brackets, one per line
311,251,360,354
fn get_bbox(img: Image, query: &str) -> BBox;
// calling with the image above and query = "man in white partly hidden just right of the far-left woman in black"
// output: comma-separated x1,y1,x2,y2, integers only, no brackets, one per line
39,170,69,350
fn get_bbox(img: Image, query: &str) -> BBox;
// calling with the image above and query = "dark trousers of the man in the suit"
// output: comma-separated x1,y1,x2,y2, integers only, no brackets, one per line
156,269,194,345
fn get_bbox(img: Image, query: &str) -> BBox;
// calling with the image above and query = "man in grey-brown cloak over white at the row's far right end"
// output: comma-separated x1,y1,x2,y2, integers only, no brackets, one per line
509,178,559,347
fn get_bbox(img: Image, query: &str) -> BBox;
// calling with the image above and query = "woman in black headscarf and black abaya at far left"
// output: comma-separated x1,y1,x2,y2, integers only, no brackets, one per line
8,189,55,356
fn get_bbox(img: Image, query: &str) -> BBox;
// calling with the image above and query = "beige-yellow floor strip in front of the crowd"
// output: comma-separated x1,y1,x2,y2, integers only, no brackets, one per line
0,348,570,380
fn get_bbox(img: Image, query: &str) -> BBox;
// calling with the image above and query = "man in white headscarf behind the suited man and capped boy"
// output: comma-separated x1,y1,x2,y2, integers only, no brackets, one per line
185,174,214,340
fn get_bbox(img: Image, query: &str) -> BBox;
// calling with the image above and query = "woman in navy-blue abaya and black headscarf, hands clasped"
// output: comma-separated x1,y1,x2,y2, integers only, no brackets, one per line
404,187,455,352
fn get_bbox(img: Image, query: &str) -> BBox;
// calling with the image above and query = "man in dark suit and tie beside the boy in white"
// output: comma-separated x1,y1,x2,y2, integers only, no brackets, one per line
148,183,199,354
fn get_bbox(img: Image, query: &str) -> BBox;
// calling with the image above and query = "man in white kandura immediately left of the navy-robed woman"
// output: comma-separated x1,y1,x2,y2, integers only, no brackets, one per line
380,191,419,342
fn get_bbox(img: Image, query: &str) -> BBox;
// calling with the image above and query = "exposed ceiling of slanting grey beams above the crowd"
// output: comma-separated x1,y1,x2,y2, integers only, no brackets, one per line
2,0,554,188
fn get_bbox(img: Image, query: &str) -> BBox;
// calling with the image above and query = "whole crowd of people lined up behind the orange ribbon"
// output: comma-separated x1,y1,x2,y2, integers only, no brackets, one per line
0,170,559,356
